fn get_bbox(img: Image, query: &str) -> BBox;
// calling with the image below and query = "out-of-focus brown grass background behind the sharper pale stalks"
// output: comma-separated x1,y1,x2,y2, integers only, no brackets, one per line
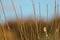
0,20,60,40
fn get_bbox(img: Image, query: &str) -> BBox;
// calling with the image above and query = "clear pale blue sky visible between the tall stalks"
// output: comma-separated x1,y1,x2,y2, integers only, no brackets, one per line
0,0,60,20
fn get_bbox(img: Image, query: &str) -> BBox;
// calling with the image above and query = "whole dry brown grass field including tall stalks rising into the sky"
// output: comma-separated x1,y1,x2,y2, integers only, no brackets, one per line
0,0,60,40
